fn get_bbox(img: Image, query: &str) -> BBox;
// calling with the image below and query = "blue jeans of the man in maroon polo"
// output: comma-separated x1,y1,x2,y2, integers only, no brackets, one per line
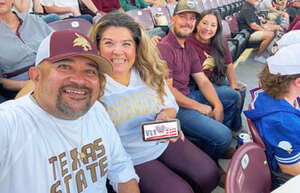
177,85,239,160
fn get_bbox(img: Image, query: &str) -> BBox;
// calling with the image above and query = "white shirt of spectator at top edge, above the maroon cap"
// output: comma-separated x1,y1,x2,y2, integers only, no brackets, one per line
40,0,79,18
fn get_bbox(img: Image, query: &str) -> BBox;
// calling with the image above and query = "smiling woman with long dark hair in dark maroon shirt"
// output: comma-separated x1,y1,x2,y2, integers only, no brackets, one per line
187,10,245,131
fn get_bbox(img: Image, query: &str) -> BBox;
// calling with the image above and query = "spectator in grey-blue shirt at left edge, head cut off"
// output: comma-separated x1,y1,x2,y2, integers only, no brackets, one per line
0,0,53,102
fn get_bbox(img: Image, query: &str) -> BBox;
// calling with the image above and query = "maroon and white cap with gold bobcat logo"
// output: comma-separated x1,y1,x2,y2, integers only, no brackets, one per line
35,30,112,74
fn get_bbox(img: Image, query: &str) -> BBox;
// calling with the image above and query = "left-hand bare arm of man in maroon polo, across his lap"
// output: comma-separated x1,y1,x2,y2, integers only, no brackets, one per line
167,79,212,117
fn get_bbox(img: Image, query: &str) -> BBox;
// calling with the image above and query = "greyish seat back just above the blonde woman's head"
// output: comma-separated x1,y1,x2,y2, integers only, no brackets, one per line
126,9,154,30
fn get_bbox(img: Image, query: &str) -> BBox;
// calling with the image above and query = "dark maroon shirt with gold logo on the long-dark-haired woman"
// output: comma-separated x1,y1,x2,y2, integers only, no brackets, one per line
187,34,232,78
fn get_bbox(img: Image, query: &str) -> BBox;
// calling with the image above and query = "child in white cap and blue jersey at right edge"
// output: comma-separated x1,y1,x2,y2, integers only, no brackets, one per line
244,43,300,188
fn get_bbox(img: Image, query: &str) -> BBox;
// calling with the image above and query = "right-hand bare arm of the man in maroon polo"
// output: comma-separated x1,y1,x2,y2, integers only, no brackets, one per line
192,72,224,123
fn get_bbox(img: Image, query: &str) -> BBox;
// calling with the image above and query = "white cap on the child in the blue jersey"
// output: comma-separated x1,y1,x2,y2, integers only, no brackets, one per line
267,43,300,75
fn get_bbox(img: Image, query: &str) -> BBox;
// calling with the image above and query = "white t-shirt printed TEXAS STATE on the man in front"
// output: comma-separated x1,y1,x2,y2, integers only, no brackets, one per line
0,95,137,193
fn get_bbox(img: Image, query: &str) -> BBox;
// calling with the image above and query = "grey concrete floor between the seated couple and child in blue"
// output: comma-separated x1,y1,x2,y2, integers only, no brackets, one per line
213,50,264,193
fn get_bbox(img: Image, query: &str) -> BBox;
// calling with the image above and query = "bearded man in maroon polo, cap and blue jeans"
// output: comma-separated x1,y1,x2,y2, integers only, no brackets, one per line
158,0,239,164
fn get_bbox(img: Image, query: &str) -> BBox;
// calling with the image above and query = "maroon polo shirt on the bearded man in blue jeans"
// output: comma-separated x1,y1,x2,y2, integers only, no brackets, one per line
157,31,202,96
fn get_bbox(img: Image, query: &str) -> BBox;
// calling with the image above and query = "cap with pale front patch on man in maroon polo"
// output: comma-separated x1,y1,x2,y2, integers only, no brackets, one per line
173,0,200,15
